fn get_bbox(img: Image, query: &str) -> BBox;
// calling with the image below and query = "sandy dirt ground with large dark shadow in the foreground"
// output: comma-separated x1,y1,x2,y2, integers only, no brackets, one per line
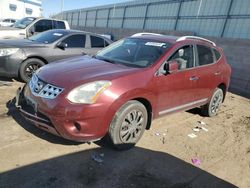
0,78,250,188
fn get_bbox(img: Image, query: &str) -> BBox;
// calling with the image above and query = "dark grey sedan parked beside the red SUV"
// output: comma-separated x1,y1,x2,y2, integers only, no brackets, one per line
0,29,112,82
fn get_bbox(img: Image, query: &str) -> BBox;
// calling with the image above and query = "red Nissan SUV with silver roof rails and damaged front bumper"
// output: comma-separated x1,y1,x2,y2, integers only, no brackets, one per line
16,33,231,149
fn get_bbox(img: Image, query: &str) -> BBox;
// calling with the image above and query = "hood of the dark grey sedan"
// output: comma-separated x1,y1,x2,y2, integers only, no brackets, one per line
0,39,46,48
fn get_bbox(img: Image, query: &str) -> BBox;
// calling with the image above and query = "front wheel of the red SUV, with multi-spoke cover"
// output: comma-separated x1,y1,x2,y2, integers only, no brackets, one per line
109,100,148,150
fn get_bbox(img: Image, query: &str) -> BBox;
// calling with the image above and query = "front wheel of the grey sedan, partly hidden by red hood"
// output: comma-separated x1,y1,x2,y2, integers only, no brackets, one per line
19,58,45,82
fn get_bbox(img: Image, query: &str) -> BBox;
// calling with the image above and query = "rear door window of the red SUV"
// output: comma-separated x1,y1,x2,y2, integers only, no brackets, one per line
197,45,214,66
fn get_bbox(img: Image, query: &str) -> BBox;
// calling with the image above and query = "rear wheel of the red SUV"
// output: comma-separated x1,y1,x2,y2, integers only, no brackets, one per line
201,88,224,117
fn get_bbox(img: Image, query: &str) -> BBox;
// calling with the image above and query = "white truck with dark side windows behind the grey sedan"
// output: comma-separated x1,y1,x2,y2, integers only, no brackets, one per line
0,17,69,39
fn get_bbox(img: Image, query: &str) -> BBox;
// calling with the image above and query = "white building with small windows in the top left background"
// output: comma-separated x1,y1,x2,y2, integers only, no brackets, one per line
0,0,42,19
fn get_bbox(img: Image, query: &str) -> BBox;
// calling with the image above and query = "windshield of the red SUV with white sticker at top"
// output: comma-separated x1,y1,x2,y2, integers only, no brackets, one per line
96,38,170,67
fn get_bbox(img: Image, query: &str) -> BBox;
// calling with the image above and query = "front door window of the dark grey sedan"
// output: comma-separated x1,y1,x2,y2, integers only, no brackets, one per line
62,34,86,48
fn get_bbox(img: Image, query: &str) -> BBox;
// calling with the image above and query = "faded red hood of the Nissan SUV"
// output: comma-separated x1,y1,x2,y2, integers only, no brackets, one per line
36,56,139,89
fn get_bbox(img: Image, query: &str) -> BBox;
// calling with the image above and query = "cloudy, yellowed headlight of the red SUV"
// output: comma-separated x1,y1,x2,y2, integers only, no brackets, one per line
67,80,111,104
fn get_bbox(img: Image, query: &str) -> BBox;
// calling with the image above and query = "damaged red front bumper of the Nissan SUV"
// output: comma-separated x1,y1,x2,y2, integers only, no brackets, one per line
16,85,111,142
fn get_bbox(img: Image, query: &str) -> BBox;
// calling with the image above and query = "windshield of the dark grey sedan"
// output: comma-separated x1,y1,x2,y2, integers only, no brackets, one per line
29,30,67,44
